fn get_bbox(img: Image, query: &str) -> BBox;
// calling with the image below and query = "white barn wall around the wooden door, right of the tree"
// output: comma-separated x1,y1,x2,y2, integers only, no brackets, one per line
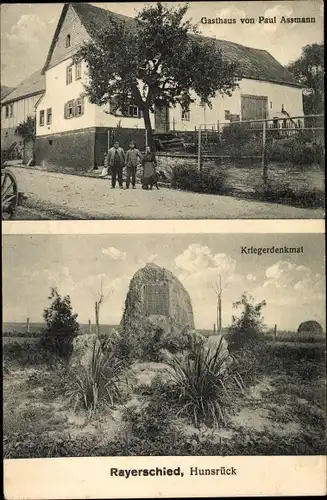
169,79,303,131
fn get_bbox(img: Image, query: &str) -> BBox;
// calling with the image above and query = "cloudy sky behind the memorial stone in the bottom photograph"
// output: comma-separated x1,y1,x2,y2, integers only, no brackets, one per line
3,234,326,330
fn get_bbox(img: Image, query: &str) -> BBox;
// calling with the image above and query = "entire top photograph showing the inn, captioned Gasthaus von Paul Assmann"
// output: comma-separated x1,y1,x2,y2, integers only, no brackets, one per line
1,0,325,221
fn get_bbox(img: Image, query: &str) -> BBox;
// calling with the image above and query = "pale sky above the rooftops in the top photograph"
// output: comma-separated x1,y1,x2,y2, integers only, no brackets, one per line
1,0,323,86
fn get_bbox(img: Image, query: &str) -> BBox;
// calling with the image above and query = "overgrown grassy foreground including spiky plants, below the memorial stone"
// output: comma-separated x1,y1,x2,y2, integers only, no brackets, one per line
4,332,326,458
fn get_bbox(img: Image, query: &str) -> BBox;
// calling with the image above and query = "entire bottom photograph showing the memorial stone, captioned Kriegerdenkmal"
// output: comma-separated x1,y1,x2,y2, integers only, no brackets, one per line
2,230,326,459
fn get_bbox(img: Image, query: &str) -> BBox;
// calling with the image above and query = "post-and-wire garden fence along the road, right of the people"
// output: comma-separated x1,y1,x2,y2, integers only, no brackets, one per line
195,114,324,180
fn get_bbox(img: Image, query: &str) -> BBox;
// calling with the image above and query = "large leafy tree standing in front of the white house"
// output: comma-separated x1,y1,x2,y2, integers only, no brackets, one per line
75,2,238,145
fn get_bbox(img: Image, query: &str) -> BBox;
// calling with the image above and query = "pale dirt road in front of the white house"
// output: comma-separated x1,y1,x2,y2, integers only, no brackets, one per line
13,167,324,220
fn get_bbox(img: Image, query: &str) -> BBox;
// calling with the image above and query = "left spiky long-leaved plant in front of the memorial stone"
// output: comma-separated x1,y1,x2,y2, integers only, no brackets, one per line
67,342,121,415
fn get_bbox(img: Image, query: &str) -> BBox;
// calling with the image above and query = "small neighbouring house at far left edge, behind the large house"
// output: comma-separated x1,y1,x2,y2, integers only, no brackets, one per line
1,70,45,156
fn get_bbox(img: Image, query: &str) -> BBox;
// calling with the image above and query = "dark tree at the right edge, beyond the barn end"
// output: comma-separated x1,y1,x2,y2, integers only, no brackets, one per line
288,43,325,115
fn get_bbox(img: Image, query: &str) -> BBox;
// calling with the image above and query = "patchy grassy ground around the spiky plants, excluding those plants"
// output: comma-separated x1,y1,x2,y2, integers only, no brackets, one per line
4,326,326,458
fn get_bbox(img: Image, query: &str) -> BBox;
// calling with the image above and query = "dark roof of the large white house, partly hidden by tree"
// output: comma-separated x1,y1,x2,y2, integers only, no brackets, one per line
43,3,300,87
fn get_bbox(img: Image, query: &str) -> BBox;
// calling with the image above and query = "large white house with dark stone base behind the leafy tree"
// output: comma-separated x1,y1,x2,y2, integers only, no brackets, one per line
36,3,303,170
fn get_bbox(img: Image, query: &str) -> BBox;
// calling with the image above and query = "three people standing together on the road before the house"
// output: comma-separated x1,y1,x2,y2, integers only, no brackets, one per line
104,141,159,189
